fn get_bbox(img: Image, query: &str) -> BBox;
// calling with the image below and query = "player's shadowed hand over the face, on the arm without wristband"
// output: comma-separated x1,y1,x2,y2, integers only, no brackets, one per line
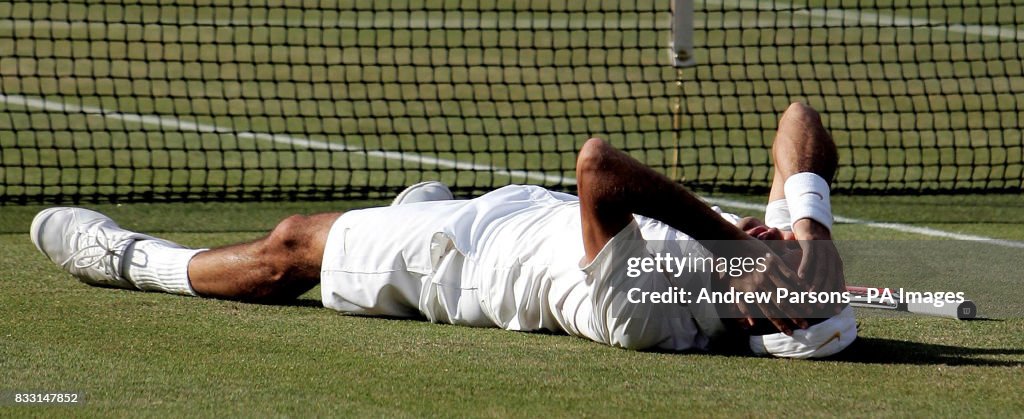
726,239,808,335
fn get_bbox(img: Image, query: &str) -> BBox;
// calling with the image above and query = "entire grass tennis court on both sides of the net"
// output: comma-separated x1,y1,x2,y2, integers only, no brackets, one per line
0,0,1024,417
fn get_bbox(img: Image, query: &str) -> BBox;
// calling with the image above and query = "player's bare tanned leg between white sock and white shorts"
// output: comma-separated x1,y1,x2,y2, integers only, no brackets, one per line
188,213,341,302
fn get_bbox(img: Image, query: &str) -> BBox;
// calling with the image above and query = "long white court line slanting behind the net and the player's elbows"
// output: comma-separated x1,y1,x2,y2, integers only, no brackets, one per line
0,93,1024,249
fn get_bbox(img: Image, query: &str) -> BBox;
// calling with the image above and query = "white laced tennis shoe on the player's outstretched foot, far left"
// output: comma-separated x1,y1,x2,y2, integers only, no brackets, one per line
30,207,180,289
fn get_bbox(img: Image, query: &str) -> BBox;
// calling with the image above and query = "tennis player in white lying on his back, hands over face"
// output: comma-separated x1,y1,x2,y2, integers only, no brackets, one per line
31,103,856,358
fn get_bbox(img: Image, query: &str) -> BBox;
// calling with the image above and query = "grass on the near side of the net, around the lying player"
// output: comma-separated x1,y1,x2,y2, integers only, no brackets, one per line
0,196,1024,416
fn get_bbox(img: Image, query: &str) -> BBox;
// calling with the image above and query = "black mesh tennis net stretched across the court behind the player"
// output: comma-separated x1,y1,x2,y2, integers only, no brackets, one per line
0,0,1024,203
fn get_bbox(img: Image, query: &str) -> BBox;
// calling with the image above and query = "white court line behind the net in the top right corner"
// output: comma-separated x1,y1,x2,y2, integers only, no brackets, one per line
703,0,1024,41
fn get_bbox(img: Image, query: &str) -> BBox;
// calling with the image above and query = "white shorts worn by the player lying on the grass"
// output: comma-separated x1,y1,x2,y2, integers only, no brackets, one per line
321,201,495,327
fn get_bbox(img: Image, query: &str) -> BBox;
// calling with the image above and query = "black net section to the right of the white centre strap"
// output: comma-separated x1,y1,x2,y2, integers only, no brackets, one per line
680,0,1024,193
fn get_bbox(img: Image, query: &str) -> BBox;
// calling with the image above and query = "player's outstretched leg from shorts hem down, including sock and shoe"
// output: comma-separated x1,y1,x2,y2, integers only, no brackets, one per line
31,207,340,301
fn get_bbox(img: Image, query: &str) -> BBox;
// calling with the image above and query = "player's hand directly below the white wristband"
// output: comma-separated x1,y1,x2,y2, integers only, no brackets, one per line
793,218,846,312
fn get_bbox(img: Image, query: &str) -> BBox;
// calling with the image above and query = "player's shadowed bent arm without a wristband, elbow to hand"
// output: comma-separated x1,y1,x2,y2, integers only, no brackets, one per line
577,138,807,333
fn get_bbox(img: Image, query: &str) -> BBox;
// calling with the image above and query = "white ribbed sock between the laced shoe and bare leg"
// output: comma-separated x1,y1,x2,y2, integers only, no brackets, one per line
122,240,206,296
